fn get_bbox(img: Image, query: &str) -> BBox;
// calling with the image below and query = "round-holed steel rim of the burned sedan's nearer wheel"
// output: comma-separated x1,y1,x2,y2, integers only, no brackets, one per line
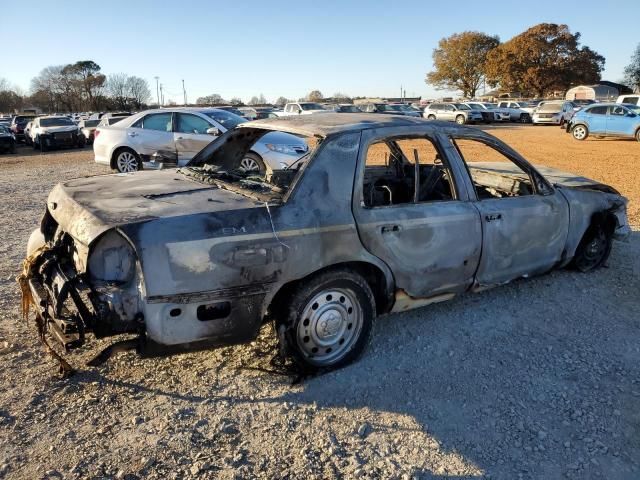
296,288,364,366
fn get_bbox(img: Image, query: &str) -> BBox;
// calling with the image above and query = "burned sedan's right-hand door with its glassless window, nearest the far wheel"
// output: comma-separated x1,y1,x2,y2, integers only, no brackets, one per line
452,137,569,285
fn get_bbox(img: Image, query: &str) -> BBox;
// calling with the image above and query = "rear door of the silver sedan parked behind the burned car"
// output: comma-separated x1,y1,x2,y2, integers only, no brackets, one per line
128,112,175,161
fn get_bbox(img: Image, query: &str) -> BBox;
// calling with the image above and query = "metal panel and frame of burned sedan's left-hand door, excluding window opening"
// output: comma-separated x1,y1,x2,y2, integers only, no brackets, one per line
353,129,482,297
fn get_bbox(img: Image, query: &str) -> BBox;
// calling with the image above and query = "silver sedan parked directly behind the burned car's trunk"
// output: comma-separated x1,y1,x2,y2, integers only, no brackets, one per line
93,108,308,174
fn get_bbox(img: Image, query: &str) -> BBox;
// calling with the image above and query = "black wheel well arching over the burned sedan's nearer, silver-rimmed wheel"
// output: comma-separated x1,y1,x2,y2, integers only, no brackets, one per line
269,262,393,316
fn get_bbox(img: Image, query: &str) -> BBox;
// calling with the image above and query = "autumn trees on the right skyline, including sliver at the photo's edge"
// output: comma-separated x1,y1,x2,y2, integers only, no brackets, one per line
425,23,640,98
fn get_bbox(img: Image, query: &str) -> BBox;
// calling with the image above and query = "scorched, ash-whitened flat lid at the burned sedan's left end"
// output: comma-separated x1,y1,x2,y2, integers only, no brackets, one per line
47,170,262,245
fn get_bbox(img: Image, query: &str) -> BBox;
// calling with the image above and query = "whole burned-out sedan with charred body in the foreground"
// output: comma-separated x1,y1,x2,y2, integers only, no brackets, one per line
20,114,629,370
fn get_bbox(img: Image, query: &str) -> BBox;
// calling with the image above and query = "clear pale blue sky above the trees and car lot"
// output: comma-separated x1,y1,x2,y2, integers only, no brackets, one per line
0,0,640,101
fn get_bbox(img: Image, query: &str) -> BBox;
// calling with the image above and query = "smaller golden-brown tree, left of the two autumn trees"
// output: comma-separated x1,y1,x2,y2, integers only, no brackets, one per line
426,32,500,98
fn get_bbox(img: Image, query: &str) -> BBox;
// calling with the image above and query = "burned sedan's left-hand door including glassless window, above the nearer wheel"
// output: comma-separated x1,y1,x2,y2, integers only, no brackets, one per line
353,129,482,297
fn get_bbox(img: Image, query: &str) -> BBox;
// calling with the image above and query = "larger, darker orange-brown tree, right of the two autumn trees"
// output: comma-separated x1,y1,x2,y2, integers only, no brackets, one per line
486,23,605,97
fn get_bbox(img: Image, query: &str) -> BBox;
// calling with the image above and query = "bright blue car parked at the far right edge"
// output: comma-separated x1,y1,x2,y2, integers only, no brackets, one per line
570,103,640,142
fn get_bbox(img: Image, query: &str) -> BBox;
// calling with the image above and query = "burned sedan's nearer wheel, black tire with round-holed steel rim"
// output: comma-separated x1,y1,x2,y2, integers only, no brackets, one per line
276,269,376,372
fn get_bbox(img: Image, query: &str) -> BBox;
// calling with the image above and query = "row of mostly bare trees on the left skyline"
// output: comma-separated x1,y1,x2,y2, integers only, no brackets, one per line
0,60,151,113
